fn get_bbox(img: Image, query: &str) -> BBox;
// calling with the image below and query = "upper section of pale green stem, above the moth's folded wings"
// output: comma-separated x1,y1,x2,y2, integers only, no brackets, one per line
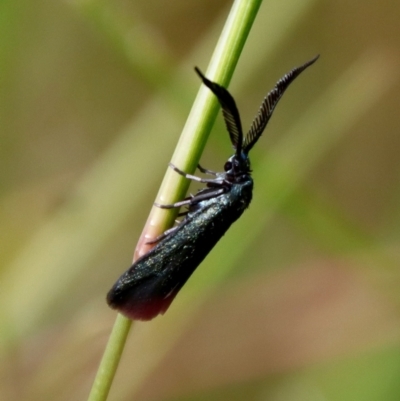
135,0,261,259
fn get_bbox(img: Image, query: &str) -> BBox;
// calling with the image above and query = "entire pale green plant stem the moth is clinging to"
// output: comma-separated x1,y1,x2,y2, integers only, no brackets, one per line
88,0,262,401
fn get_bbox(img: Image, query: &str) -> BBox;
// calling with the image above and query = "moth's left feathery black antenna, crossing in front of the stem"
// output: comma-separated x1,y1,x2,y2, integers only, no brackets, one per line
195,67,243,153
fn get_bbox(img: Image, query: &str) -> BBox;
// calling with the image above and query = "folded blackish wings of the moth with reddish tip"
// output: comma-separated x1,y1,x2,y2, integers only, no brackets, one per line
107,177,253,320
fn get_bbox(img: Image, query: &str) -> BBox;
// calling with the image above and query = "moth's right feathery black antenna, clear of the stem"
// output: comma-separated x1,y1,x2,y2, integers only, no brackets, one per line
243,55,319,154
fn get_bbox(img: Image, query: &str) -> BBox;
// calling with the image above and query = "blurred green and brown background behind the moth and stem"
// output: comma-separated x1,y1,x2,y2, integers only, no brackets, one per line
0,0,400,401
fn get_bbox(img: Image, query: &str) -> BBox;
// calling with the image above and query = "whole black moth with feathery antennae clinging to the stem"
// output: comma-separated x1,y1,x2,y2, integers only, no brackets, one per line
107,56,318,320
